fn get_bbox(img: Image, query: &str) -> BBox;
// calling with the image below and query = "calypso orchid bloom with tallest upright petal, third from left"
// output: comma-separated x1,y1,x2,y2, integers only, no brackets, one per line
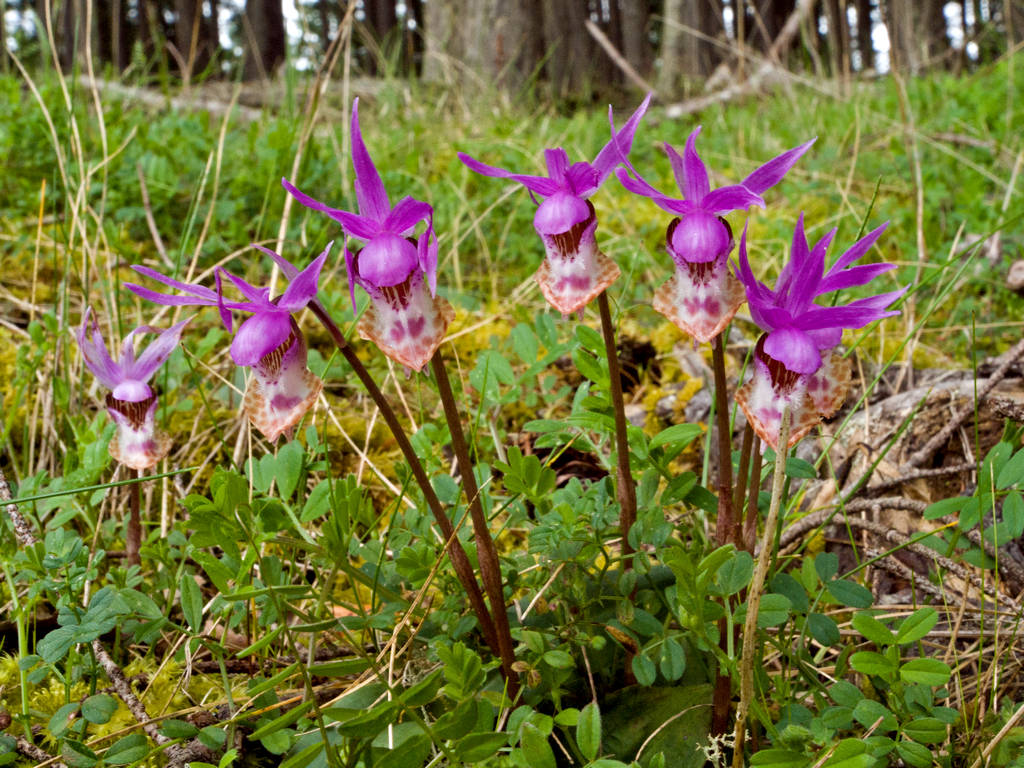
282,99,455,371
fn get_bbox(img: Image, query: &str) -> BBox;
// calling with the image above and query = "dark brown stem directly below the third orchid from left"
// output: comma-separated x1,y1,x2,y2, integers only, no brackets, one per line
430,350,519,698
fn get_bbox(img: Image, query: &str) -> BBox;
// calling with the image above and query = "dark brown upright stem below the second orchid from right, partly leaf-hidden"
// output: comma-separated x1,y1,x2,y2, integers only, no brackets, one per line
712,334,733,734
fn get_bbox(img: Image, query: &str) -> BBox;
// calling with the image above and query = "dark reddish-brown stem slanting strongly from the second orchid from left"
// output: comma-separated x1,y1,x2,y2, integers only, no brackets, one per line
309,302,501,657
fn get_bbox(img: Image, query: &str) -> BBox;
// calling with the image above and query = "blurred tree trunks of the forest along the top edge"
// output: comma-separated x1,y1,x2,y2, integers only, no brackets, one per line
0,0,1024,96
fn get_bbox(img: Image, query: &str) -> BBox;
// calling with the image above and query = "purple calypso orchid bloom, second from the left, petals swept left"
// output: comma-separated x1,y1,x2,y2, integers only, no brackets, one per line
126,243,334,441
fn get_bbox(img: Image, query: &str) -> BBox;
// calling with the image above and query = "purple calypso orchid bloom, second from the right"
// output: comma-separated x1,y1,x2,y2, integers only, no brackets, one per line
617,127,814,342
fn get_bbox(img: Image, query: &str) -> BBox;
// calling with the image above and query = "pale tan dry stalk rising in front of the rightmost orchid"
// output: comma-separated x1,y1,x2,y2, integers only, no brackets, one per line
732,408,790,768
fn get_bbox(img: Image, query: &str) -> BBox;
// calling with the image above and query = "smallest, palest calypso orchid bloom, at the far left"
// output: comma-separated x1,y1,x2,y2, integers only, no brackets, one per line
77,307,188,470
